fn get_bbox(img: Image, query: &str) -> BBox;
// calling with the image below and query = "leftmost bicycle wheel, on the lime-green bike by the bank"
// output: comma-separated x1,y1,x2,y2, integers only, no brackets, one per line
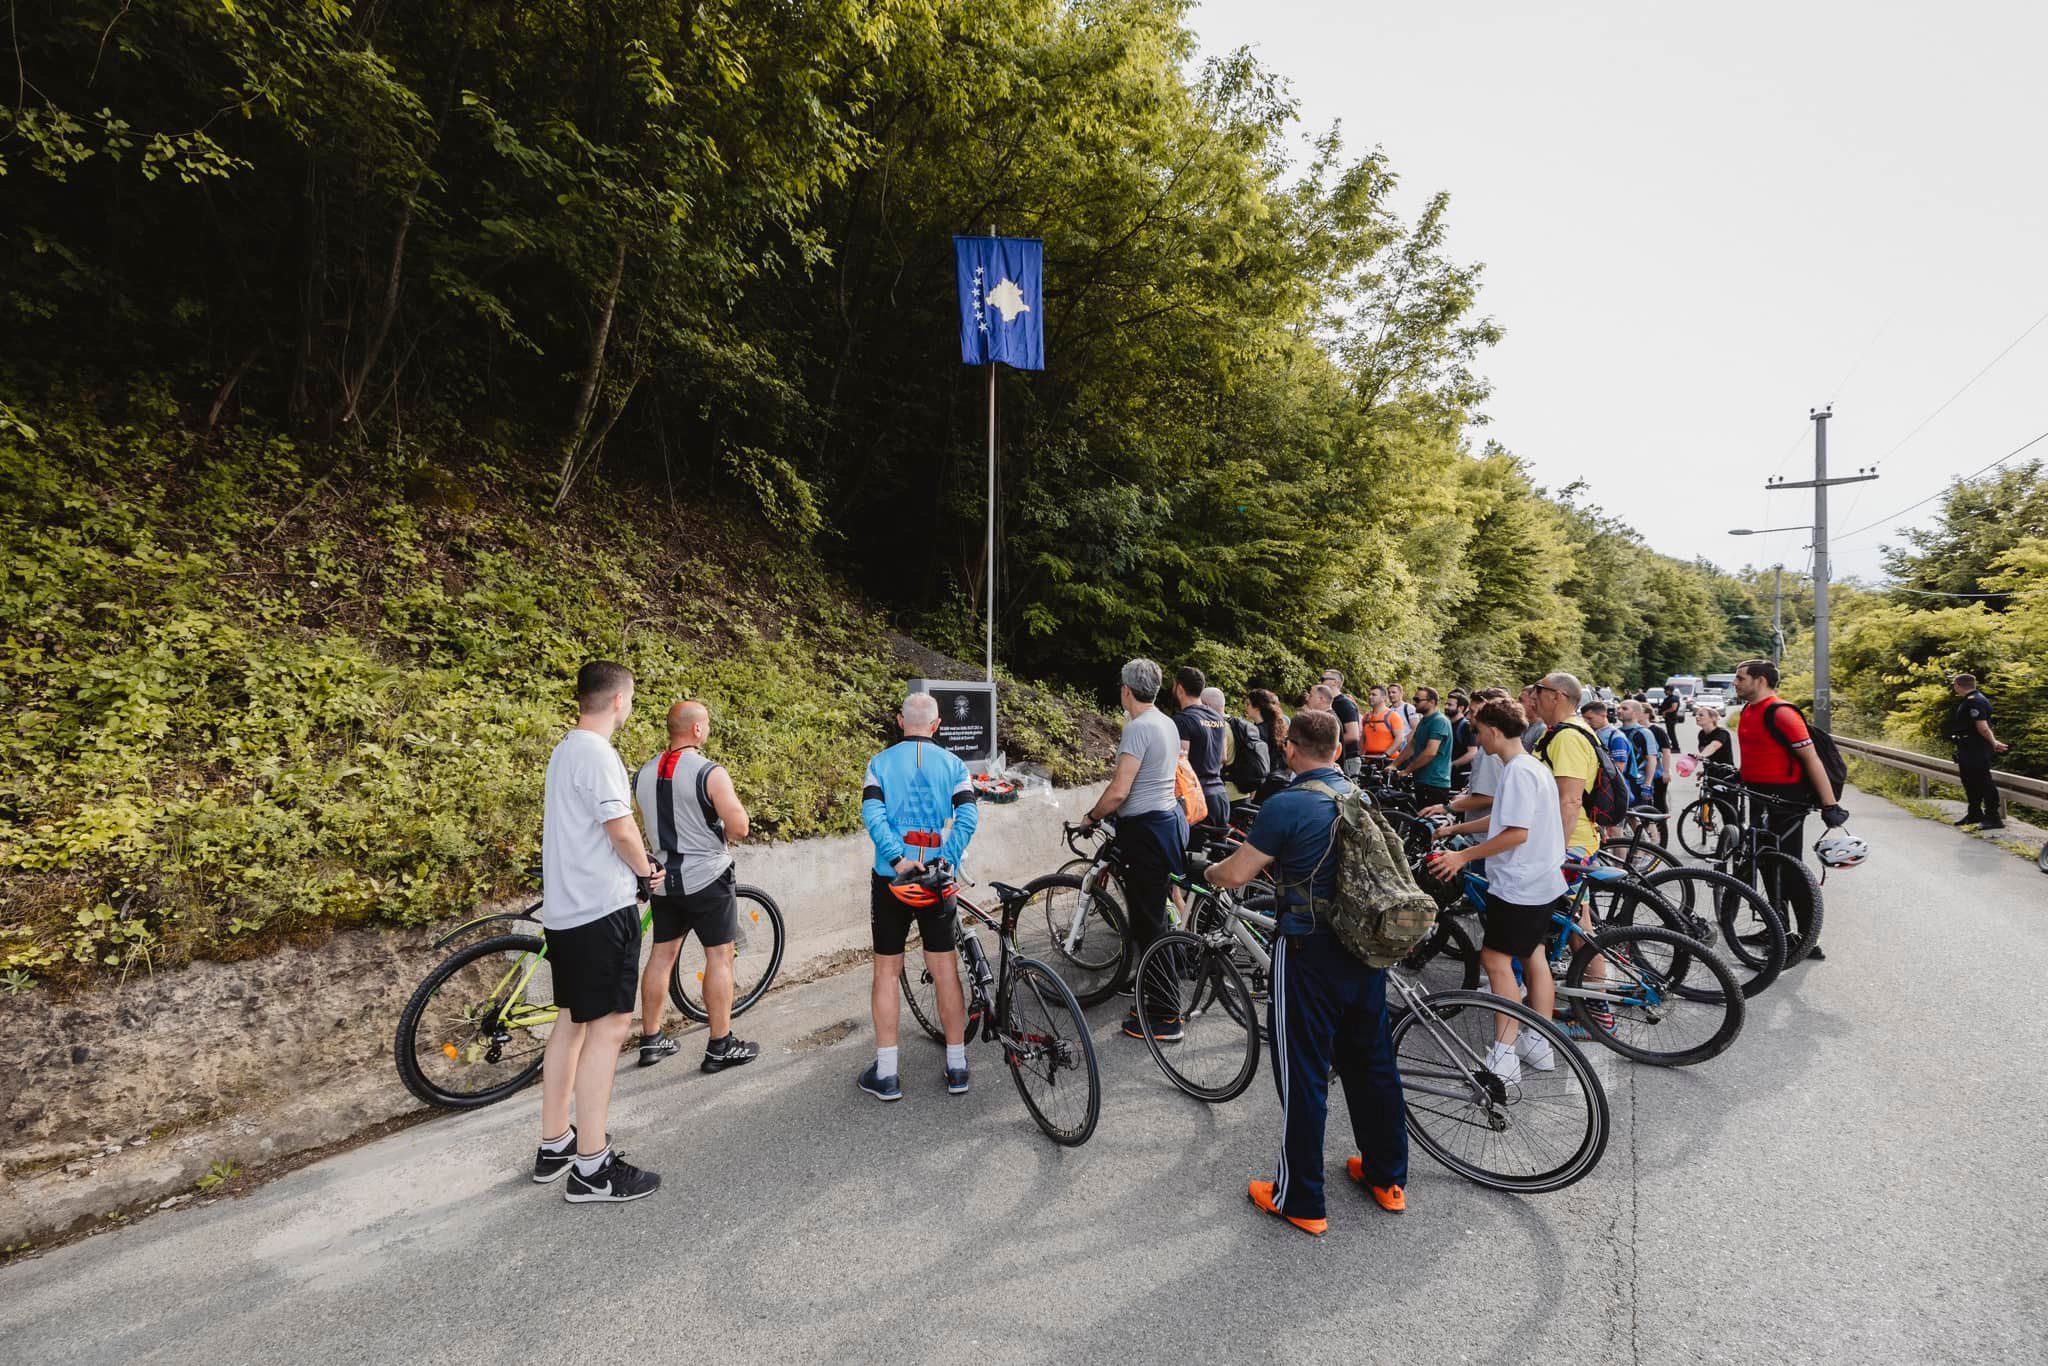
393,934,555,1110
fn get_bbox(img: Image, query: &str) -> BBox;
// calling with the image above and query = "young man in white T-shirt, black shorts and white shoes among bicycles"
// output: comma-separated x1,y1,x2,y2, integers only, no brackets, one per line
1430,698,1565,1085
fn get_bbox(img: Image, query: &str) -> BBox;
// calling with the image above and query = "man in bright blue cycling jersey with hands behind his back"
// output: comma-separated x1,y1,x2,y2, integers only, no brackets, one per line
858,692,979,1100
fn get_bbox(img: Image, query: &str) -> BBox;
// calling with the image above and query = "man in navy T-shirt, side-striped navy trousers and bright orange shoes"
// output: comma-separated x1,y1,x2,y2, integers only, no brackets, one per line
1206,711,1407,1233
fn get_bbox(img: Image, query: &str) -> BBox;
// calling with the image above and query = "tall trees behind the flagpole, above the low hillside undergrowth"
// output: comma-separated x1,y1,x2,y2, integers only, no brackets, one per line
0,0,1753,704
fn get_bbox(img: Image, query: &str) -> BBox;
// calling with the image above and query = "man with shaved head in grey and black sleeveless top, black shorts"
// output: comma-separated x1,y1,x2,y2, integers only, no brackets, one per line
633,702,760,1071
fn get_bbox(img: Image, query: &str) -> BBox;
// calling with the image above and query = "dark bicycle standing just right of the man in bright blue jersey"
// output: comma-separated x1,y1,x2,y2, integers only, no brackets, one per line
897,860,1102,1147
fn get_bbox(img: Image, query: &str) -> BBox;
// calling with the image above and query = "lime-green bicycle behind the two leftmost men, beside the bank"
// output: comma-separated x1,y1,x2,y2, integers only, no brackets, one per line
391,883,784,1110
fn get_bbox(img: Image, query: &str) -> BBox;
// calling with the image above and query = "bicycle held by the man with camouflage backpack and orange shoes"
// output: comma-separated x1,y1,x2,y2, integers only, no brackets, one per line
1137,883,1610,1194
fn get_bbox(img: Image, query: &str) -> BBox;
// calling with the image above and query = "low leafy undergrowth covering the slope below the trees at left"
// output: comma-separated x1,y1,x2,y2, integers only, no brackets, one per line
0,408,1100,975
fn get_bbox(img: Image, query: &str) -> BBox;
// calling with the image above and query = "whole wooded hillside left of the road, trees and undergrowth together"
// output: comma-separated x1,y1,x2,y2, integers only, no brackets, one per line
0,0,1767,973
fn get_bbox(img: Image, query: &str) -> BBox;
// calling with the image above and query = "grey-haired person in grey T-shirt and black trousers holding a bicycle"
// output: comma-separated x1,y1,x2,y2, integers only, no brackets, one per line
1081,659,1188,1040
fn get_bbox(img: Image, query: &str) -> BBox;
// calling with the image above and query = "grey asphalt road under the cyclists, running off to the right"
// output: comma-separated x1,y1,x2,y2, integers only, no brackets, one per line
0,778,2048,1366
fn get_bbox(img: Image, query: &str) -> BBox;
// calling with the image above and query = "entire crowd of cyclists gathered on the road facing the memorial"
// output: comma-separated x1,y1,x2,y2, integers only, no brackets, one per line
532,659,1859,1233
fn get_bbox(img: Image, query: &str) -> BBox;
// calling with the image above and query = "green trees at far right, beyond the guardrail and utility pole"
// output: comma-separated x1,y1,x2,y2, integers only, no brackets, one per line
1798,461,2048,778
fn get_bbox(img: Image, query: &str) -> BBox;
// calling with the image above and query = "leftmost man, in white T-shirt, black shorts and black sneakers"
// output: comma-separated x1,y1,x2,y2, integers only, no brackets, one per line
532,659,662,1204
